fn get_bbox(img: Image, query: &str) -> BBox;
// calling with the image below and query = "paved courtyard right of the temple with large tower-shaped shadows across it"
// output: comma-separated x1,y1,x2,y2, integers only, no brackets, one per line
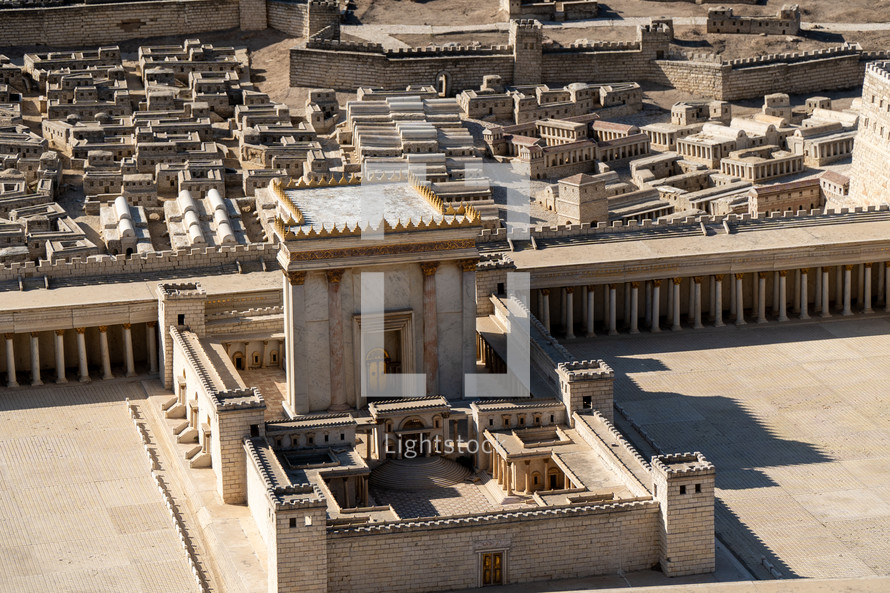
566,316,890,578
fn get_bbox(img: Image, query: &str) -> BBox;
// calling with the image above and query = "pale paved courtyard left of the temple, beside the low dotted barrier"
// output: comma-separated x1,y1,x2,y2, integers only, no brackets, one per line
0,381,197,593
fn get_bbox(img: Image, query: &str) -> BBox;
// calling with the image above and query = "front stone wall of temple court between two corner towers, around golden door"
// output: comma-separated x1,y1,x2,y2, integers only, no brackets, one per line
327,502,660,593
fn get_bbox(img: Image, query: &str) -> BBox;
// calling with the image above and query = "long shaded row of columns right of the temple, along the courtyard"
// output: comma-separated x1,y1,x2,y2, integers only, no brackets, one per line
533,262,890,339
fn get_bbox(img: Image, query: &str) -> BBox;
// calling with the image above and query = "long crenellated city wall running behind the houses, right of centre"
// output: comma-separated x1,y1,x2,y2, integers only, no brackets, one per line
291,27,890,101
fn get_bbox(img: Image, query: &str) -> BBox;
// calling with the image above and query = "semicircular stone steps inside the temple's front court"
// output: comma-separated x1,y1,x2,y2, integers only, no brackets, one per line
370,456,472,492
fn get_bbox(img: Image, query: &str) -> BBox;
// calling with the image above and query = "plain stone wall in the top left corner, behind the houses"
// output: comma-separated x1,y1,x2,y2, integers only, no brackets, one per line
0,0,243,47
